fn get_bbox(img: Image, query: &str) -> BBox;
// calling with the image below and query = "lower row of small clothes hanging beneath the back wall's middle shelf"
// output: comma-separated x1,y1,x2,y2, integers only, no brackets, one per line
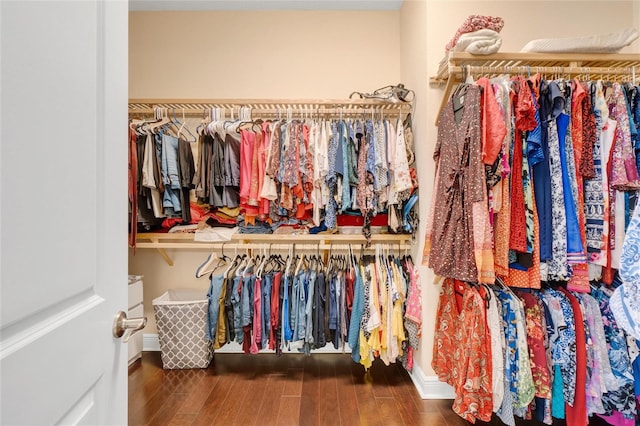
200,247,421,371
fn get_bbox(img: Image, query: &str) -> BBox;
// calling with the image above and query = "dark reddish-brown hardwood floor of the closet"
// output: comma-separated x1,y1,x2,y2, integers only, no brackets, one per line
129,352,467,426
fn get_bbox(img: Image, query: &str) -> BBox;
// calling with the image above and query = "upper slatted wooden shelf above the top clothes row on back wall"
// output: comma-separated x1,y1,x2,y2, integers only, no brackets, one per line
129,99,411,116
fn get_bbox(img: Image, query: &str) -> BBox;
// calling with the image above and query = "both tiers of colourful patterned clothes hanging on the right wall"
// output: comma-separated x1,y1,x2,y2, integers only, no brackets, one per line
424,76,640,425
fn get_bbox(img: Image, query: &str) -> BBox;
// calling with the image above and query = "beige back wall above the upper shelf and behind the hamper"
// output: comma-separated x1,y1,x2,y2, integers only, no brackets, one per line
129,11,402,335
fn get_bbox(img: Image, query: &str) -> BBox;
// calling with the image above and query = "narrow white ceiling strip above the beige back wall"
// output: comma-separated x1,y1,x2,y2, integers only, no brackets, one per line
129,0,402,11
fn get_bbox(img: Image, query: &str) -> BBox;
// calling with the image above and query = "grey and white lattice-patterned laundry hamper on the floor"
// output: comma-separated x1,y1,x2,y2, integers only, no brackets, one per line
152,289,213,370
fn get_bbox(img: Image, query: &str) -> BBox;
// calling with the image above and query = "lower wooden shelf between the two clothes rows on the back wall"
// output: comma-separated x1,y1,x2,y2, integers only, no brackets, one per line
136,232,411,266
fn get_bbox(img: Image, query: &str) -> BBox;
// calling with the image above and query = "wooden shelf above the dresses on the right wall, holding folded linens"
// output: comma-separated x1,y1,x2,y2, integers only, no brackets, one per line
430,52,640,84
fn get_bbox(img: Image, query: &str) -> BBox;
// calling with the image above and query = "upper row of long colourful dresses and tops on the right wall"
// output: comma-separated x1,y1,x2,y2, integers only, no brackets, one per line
423,76,639,292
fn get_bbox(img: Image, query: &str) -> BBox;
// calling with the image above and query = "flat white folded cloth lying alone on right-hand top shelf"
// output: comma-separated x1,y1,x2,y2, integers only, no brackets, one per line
522,27,638,53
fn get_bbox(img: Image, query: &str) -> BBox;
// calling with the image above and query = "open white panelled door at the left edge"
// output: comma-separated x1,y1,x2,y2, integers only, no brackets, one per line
0,0,128,425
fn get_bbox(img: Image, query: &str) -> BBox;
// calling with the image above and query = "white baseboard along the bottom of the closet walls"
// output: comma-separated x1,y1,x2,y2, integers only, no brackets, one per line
142,333,455,399
